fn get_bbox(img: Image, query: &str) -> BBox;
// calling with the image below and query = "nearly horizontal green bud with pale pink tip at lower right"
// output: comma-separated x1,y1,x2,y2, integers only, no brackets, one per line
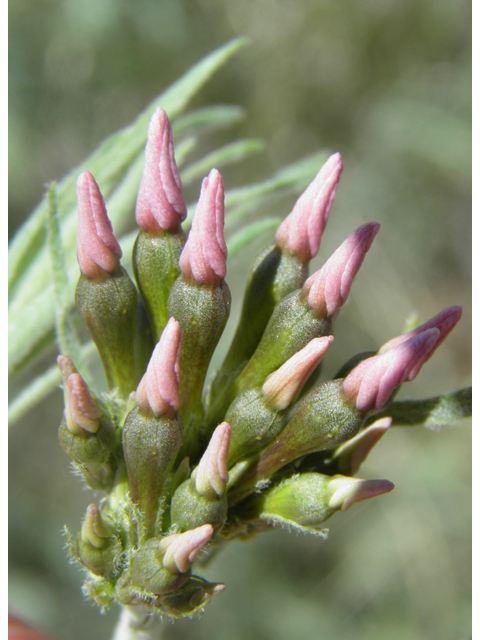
246,473,394,530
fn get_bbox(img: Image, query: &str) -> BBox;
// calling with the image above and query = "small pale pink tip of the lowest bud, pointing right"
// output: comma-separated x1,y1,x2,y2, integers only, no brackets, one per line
158,524,213,573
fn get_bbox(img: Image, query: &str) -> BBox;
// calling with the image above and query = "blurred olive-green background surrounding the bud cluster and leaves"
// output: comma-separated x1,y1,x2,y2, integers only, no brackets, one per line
9,0,471,640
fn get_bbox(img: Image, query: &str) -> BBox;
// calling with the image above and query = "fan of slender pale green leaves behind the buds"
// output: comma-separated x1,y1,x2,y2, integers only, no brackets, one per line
9,38,336,420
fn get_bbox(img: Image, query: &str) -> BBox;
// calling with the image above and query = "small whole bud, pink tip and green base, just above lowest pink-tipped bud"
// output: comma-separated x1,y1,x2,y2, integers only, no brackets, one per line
170,422,231,531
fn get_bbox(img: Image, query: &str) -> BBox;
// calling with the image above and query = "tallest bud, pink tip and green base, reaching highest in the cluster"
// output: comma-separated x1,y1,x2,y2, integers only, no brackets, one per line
133,108,187,341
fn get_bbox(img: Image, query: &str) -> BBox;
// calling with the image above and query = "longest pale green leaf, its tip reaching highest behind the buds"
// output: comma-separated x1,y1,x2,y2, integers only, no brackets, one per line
9,38,247,371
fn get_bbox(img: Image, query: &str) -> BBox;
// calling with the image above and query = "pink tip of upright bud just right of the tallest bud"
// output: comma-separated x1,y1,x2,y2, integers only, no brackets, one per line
179,169,227,286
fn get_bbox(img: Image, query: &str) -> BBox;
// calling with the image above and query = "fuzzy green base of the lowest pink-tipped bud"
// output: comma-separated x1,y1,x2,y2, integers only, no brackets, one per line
115,538,191,604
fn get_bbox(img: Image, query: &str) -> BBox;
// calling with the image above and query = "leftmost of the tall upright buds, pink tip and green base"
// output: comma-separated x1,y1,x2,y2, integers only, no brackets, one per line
75,171,137,398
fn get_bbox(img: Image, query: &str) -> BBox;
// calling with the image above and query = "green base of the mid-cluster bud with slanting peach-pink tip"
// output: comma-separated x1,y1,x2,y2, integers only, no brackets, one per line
225,387,285,467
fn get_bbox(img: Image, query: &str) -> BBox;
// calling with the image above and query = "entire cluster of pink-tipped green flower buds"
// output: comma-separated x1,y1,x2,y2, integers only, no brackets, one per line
58,109,461,617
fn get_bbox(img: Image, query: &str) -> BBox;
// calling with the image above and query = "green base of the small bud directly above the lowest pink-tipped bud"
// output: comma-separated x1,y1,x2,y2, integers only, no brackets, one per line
170,478,228,532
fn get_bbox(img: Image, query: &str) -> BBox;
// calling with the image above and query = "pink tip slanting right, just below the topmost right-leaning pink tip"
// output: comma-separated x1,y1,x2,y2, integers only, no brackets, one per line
303,222,380,317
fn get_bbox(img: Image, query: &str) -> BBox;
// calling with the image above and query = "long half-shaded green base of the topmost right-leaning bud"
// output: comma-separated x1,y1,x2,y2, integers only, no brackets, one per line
210,243,308,408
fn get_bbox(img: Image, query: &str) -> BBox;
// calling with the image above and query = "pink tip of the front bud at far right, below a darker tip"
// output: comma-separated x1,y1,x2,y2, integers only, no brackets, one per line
342,329,440,413
